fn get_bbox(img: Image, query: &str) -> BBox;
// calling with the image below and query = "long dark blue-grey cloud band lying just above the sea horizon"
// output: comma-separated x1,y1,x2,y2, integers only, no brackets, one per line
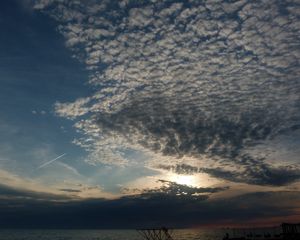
0,189,300,229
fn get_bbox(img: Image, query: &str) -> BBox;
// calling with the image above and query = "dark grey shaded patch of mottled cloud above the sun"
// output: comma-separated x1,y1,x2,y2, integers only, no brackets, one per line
97,96,288,159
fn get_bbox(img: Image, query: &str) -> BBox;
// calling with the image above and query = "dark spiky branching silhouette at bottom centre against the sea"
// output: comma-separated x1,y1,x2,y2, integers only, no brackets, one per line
137,227,174,240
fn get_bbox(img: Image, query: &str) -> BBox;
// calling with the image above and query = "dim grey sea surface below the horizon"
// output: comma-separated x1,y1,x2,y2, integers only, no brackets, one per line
0,229,284,240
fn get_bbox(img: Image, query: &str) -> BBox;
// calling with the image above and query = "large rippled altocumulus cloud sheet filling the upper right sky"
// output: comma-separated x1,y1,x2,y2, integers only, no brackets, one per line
35,0,300,185
